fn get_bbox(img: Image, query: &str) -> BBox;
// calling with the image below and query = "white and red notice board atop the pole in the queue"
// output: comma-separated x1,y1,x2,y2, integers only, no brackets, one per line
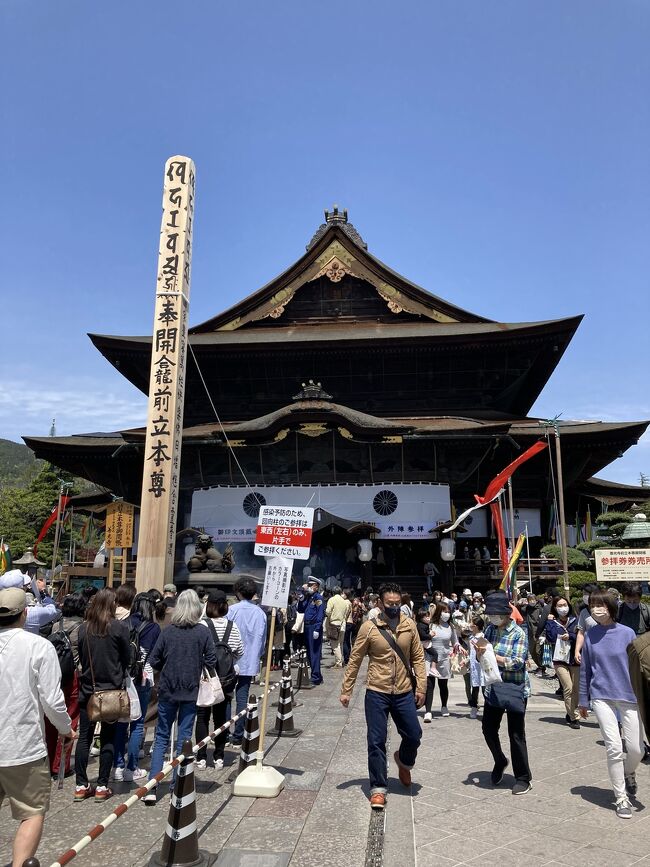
255,506,314,560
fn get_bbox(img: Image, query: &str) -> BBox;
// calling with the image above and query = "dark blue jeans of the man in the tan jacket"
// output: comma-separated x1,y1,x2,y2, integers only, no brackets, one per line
365,689,422,794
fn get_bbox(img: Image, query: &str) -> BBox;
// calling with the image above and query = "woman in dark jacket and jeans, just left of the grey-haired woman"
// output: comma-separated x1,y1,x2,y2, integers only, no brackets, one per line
113,593,161,783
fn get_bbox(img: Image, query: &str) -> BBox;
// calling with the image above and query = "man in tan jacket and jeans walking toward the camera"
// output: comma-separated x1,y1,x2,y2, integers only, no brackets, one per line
340,583,427,810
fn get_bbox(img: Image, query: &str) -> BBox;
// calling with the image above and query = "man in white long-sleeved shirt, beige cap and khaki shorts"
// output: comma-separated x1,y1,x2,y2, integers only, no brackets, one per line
0,587,76,867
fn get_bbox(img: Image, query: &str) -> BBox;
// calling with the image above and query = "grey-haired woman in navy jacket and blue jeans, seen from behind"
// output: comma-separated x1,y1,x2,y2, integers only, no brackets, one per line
143,590,217,805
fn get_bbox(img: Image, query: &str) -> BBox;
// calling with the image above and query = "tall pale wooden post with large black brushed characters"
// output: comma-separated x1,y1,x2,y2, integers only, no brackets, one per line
135,156,195,591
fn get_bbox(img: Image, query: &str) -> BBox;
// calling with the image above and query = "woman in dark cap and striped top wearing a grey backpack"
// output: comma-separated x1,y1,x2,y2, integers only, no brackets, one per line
196,589,244,771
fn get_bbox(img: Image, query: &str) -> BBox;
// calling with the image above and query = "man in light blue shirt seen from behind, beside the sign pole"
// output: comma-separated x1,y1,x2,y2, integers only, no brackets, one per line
227,578,266,746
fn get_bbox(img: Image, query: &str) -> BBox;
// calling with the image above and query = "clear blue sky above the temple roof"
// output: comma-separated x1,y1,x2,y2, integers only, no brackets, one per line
0,0,650,483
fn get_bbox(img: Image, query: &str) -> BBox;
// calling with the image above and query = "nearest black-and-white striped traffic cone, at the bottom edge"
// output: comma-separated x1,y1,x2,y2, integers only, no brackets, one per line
149,741,216,867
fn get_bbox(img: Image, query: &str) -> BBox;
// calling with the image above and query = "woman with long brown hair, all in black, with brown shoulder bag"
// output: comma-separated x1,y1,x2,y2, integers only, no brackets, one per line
74,589,129,801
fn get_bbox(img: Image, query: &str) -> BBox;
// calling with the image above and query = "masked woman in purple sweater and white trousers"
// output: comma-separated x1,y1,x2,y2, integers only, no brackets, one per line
580,590,644,819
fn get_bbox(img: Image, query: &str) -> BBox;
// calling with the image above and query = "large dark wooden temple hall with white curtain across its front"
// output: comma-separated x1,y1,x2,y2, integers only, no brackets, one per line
24,207,648,582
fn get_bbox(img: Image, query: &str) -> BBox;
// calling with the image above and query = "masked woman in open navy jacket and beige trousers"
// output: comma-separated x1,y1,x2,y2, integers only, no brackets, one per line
544,596,580,729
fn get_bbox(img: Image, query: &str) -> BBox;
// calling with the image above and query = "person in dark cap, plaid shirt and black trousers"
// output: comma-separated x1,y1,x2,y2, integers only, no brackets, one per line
476,590,532,795
